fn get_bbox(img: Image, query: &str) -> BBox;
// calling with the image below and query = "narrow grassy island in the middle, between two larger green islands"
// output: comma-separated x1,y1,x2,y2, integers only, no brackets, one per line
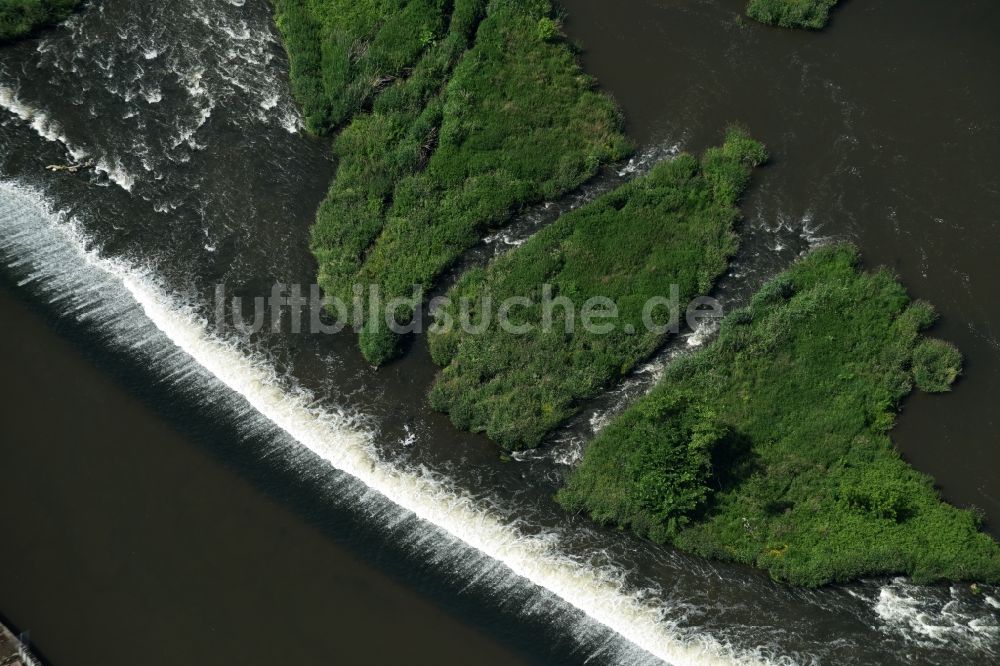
430,129,766,449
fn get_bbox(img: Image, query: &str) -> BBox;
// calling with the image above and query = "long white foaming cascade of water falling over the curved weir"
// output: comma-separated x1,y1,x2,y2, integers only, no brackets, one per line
0,183,762,664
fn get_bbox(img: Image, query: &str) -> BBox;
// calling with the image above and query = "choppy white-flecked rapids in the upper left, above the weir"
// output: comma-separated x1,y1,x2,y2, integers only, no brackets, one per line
0,0,303,205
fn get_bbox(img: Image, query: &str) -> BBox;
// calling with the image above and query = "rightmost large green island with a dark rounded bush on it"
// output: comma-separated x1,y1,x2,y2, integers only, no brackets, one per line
558,246,1000,586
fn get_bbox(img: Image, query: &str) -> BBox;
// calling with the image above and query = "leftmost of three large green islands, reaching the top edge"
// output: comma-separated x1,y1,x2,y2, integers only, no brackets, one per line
277,0,630,365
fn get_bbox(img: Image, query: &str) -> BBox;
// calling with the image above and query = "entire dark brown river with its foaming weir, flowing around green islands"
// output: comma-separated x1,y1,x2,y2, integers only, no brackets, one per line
0,0,1000,666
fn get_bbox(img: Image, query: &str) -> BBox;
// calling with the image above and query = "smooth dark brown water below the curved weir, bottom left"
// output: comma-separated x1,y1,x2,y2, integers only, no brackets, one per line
0,288,526,666
